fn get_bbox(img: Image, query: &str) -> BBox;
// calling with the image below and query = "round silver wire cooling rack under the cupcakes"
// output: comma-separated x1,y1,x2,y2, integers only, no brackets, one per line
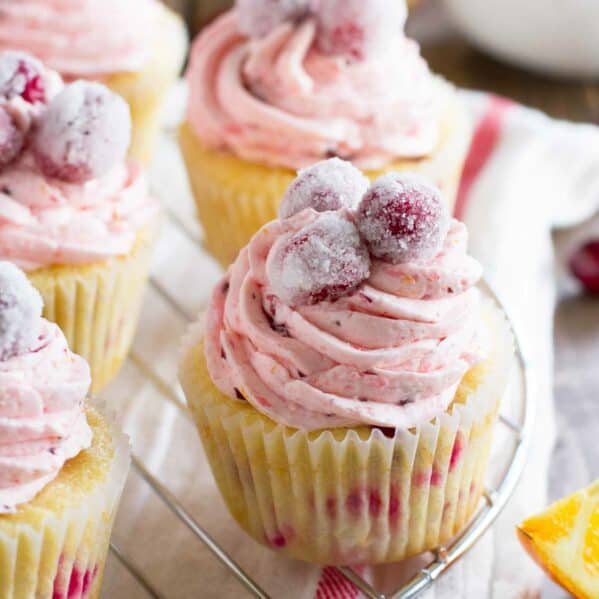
97,129,533,599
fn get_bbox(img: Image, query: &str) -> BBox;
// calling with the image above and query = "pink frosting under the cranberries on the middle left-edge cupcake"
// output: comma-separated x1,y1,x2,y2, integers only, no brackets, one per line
0,83,158,271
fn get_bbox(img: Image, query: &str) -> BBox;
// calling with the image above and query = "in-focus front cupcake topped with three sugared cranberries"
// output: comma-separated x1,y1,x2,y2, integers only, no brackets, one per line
180,159,513,565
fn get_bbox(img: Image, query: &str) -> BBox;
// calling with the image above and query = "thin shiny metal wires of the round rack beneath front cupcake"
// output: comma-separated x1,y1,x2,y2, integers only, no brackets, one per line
108,213,534,599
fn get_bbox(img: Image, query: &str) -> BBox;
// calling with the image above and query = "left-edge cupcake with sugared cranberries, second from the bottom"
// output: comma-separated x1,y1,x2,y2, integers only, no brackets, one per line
0,52,158,392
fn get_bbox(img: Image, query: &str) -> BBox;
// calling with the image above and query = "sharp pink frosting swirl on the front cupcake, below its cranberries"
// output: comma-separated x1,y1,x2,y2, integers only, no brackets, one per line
205,210,485,430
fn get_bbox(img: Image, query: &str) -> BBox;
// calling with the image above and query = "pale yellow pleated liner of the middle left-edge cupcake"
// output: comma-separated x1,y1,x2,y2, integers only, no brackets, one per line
27,228,154,393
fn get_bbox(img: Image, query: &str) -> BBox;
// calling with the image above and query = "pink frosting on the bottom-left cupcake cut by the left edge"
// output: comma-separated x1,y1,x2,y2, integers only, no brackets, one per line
0,319,92,513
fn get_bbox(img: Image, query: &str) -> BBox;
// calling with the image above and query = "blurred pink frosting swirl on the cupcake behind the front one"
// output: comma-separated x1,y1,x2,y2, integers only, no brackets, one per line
187,11,438,169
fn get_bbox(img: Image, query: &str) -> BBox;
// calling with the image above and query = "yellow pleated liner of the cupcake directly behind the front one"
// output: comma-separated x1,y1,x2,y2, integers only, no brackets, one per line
179,80,471,268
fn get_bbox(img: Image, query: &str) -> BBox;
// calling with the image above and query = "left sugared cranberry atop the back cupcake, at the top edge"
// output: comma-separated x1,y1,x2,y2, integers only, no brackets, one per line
237,0,310,37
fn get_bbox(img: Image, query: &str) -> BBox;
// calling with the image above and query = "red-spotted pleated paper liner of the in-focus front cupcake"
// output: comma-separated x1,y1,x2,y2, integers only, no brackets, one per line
180,300,513,565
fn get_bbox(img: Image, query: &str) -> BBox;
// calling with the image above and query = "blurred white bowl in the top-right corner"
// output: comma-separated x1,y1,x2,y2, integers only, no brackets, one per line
443,0,599,78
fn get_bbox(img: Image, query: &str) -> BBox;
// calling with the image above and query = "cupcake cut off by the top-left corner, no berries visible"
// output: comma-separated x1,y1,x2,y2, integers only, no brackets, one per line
0,0,187,163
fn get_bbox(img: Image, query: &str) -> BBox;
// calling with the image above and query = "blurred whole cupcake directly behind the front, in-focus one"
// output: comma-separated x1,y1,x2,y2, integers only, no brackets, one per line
180,0,470,266
